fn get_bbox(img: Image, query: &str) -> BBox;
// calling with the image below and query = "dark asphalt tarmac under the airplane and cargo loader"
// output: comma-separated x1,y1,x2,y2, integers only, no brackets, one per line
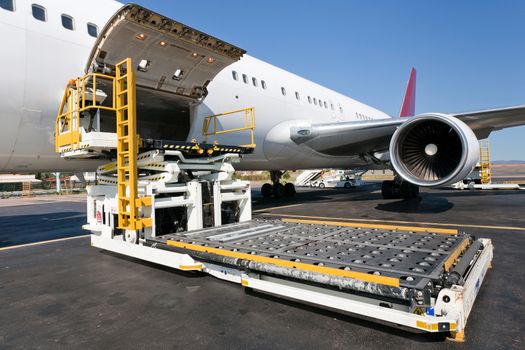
0,185,525,349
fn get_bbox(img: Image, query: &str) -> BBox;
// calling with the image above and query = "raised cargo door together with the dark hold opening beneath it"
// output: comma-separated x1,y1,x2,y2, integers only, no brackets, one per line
82,4,246,141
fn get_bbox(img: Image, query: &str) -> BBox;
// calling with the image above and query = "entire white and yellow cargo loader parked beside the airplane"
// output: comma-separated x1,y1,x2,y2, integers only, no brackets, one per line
55,59,493,340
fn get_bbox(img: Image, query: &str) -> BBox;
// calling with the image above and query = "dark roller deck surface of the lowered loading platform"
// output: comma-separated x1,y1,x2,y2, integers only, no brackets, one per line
147,220,472,290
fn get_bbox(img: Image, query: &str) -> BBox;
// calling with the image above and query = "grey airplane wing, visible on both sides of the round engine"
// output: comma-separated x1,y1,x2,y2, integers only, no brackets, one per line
290,106,525,156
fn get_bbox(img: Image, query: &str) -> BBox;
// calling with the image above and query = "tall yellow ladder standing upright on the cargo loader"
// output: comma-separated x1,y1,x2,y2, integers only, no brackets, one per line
114,58,152,230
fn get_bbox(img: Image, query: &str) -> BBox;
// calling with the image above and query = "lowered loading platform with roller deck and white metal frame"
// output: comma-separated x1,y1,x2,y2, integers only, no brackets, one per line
92,216,493,341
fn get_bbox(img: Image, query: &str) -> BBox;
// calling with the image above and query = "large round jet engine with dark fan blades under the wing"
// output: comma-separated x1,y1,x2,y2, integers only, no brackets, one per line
390,114,479,187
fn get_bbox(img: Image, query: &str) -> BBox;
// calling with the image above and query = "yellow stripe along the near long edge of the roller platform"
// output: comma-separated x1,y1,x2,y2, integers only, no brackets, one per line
166,240,399,287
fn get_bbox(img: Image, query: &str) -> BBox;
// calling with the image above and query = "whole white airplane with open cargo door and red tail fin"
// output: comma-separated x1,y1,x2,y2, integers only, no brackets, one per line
0,0,525,198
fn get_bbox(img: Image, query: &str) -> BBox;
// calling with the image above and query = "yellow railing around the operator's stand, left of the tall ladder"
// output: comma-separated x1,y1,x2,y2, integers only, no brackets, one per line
55,73,116,153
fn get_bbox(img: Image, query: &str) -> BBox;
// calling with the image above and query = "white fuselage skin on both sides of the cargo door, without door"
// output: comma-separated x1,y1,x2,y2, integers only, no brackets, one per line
0,0,390,172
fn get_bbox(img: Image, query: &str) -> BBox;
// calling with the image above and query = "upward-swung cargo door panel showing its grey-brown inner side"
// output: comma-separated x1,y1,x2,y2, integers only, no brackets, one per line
86,4,246,100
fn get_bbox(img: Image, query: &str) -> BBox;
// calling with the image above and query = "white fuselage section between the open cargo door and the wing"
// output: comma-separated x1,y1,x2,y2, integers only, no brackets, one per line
189,55,390,170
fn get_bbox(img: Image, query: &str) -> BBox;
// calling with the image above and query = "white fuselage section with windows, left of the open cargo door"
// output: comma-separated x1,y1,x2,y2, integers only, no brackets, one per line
0,0,122,172
